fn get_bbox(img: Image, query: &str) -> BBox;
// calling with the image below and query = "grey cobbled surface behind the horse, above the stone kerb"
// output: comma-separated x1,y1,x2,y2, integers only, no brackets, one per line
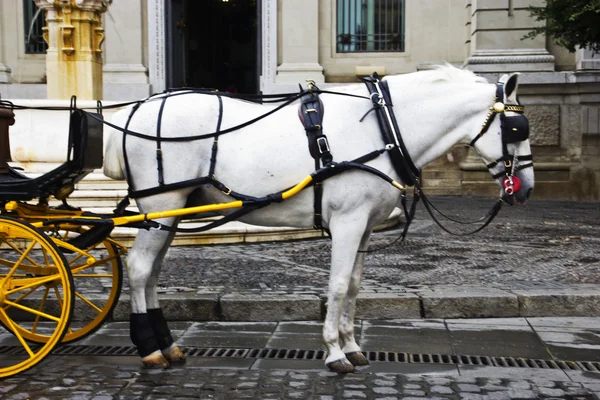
142,197,600,292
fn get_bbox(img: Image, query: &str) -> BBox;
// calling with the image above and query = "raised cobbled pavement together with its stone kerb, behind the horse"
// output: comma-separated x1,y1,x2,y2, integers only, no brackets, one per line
70,197,600,321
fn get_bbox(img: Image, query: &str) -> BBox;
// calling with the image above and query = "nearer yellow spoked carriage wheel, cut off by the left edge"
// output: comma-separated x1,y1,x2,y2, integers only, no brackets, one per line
0,216,73,378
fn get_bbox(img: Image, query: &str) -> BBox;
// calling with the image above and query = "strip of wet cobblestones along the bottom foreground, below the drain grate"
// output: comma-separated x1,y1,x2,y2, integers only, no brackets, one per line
0,363,600,400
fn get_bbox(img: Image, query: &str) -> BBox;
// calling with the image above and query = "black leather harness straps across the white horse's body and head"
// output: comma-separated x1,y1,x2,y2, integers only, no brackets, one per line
108,74,533,238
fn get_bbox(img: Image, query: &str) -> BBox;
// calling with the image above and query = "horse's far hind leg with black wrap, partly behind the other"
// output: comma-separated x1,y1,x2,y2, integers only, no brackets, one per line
145,223,185,364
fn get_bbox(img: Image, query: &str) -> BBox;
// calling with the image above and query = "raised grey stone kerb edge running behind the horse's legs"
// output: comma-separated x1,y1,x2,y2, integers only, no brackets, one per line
101,284,600,321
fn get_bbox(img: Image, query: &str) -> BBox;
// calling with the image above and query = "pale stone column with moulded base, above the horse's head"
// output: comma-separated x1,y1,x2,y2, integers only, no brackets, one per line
465,0,554,73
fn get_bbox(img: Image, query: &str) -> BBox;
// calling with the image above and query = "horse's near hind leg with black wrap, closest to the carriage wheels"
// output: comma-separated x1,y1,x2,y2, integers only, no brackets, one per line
127,230,178,368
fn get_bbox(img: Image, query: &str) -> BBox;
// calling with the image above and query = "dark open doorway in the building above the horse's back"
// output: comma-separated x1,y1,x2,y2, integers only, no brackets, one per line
169,0,259,93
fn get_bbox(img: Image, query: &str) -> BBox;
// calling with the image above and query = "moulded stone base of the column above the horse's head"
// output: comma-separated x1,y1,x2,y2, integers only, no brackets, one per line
464,49,554,72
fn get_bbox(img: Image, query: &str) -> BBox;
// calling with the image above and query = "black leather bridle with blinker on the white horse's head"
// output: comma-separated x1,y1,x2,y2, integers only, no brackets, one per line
469,82,533,196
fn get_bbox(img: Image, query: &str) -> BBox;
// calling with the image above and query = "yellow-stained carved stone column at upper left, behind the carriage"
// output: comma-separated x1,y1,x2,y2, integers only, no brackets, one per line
35,0,112,100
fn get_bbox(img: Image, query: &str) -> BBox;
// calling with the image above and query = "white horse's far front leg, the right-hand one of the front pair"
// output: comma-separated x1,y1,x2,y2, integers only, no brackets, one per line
339,229,372,367
